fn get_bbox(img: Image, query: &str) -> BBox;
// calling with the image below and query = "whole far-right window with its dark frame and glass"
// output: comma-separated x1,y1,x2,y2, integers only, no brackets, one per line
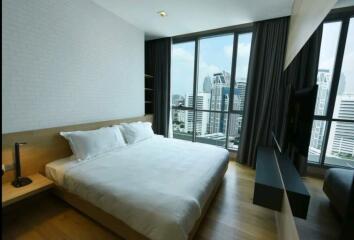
309,16,354,167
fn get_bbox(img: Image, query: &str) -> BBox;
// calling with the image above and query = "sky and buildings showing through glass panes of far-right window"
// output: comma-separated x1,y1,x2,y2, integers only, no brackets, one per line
309,19,354,167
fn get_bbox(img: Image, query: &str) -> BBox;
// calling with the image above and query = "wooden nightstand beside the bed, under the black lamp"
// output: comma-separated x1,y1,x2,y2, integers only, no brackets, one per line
2,173,54,207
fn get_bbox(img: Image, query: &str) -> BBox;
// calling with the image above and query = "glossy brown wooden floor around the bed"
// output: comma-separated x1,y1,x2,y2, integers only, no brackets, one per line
2,162,340,240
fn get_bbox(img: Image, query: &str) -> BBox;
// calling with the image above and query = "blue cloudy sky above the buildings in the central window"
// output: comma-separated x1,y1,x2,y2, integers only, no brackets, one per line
171,33,252,95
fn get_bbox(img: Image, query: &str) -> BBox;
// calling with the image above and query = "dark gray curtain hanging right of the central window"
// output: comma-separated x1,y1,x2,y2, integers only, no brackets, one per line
237,17,289,167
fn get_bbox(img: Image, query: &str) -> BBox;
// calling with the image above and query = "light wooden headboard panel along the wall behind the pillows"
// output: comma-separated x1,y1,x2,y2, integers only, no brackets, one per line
2,115,152,182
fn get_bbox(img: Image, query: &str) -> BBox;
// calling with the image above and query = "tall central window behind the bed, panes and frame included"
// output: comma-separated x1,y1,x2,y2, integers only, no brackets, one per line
171,29,252,150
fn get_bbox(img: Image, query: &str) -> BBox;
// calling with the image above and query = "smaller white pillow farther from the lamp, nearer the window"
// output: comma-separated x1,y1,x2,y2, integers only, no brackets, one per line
119,122,154,144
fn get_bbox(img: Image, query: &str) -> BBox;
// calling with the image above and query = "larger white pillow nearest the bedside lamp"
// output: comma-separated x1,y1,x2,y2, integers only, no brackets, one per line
60,127,126,160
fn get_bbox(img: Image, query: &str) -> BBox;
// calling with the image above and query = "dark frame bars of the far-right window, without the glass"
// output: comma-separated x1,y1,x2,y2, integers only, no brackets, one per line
308,7,354,169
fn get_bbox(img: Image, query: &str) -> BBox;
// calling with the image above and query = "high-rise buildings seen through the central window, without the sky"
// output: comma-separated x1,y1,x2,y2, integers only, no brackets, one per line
172,71,246,149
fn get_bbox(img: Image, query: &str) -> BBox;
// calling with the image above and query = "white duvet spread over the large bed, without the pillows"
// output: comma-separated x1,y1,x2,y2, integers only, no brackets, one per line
46,136,228,240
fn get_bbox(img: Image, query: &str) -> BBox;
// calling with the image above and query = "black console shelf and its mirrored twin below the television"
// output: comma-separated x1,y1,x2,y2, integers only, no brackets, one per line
253,147,310,219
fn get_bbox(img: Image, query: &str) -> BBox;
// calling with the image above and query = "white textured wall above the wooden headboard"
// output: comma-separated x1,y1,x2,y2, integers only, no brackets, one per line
2,0,144,133
